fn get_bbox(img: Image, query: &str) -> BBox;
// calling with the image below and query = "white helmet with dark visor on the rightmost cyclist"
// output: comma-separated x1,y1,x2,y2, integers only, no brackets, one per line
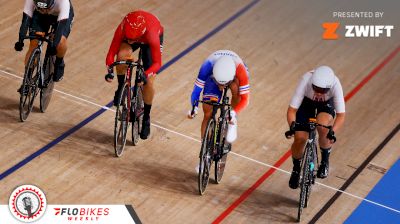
311,65,335,93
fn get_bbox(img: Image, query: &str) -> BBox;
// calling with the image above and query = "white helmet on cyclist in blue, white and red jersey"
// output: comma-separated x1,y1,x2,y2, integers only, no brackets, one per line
213,55,236,85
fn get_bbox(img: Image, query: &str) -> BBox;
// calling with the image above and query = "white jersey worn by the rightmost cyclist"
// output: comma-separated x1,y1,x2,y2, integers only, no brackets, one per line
290,71,345,113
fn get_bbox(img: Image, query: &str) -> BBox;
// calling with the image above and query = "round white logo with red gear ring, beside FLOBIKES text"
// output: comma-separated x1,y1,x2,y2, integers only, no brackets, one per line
8,185,47,223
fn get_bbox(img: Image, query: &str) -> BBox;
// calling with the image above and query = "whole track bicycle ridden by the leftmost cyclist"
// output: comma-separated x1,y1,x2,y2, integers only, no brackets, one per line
19,27,56,122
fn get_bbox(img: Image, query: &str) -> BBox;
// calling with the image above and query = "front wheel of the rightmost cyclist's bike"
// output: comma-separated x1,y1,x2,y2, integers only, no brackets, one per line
297,143,312,222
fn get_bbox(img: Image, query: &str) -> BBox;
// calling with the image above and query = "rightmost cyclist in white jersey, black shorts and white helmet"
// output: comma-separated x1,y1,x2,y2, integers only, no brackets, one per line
287,66,345,189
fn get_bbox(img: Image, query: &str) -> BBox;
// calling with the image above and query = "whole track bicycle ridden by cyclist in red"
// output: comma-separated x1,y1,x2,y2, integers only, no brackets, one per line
110,52,146,157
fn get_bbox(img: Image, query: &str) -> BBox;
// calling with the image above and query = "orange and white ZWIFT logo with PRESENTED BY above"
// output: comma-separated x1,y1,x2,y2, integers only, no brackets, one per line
322,12,395,40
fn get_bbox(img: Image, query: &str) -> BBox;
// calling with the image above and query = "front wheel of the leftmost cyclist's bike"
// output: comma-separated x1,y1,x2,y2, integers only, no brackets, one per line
19,49,40,121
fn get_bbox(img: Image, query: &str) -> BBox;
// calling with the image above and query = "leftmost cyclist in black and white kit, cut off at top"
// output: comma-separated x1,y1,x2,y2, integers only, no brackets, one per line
14,0,74,82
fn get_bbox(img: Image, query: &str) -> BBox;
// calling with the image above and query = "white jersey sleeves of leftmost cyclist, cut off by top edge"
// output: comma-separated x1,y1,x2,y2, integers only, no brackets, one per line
24,0,71,21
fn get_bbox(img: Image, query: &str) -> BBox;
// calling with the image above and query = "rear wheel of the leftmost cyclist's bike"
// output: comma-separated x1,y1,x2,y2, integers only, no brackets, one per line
40,56,55,113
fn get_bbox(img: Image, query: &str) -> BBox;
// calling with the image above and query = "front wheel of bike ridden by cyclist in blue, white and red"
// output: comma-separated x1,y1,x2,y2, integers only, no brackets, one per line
198,119,215,195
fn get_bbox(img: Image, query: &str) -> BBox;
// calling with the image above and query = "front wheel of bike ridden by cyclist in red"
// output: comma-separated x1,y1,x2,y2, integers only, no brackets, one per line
114,84,130,157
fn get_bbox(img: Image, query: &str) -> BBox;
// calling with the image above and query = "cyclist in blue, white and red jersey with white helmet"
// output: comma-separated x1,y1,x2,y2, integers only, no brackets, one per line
188,50,250,143
